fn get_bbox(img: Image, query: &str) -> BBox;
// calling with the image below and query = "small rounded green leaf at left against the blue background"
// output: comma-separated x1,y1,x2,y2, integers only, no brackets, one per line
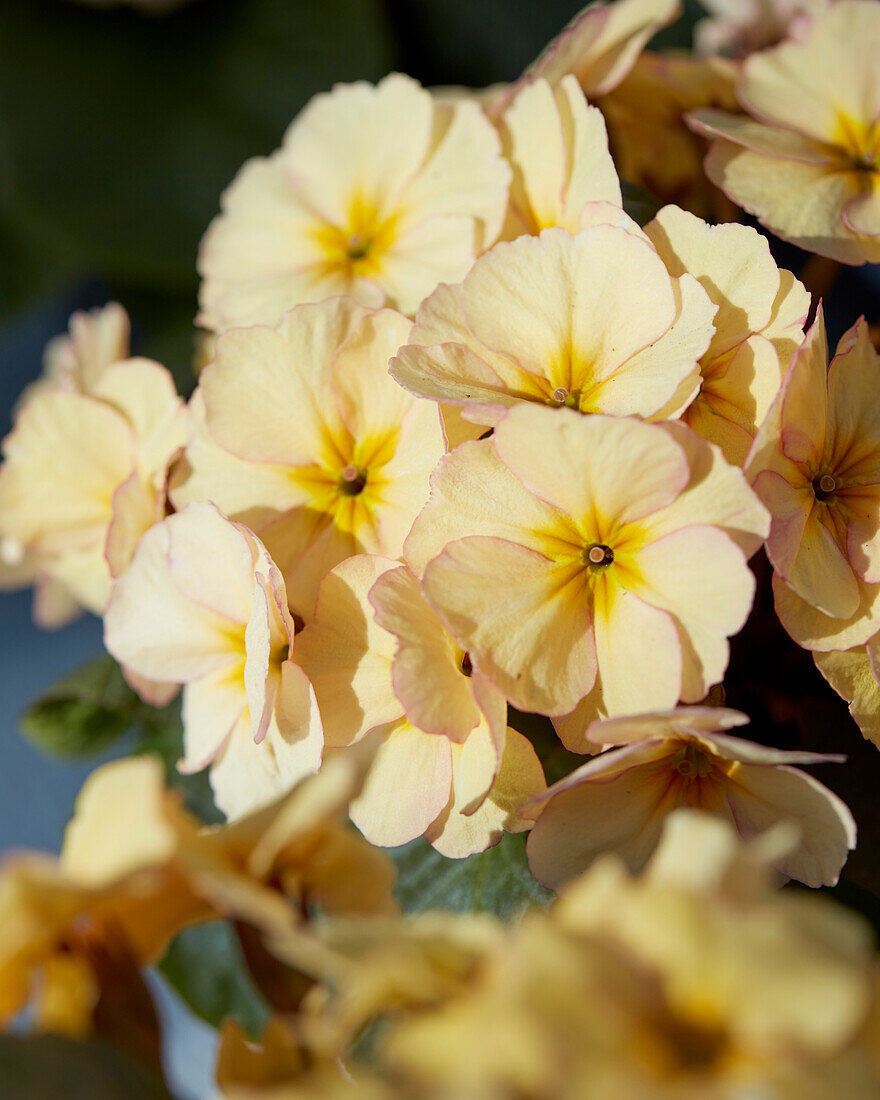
21,657,144,756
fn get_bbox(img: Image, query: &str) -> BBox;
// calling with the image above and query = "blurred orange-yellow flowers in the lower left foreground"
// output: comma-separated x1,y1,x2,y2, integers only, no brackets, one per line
0,745,395,1038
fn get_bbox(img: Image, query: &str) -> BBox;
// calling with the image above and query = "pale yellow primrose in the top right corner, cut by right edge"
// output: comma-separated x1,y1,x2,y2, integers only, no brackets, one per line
691,0,880,264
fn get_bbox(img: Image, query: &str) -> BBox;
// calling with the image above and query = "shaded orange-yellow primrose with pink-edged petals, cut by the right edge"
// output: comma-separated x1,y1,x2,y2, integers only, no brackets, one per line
746,310,880,650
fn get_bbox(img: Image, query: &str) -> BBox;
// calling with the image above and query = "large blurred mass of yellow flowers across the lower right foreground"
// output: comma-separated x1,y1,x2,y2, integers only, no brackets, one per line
218,812,880,1100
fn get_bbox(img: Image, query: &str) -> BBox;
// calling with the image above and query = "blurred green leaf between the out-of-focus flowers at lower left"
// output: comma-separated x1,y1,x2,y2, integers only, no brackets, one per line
158,921,271,1038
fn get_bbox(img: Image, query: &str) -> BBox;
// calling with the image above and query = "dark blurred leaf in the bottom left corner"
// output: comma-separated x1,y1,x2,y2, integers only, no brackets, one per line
0,1035,171,1100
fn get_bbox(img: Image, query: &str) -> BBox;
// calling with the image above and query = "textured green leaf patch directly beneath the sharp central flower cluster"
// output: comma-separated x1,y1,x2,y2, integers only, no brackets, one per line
388,833,553,920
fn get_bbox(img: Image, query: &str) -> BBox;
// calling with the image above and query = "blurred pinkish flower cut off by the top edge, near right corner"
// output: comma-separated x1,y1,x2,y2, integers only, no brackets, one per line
694,0,835,57
